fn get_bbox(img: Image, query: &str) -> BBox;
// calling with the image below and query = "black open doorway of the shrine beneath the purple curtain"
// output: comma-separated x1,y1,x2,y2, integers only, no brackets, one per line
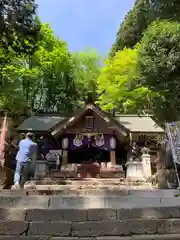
68,145,109,164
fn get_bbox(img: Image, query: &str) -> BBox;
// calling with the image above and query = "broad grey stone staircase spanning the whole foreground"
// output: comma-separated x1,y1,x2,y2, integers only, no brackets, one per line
0,190,180,240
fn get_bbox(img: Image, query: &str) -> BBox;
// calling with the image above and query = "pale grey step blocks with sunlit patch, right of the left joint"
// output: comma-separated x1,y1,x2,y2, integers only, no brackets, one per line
49,196,180,209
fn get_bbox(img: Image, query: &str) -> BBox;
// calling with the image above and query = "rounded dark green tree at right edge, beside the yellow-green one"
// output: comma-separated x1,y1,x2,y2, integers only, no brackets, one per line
138,21,180,122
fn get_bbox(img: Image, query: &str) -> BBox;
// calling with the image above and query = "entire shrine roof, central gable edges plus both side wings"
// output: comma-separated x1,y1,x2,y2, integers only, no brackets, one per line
17,104,164,135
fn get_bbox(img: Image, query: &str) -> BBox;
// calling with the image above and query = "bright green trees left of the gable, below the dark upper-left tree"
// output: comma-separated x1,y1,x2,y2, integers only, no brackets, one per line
0,24,101,114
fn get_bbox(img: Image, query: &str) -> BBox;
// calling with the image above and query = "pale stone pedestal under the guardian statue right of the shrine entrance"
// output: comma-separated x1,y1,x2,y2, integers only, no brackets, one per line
126,161,144,178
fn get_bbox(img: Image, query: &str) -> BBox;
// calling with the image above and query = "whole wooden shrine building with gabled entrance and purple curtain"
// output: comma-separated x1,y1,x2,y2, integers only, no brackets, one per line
17,104,164,177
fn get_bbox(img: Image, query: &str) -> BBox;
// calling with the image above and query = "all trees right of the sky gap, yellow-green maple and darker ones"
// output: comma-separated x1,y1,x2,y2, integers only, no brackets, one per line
98,0,180,123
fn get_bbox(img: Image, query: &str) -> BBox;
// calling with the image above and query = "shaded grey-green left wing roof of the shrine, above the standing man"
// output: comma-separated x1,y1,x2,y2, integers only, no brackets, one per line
17,115,65,132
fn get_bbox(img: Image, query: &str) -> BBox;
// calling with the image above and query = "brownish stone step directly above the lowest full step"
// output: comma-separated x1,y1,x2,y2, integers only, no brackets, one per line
0,206,180,223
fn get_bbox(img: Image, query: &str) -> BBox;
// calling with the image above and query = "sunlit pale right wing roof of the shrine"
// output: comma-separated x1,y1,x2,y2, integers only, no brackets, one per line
115,114,164,133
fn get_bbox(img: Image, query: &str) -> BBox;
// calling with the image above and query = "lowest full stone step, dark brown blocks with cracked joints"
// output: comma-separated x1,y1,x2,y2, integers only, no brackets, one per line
0,215,180,237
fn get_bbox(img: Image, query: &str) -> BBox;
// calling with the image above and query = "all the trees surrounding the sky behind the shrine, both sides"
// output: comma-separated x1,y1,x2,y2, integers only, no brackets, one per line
0,0,180,123
